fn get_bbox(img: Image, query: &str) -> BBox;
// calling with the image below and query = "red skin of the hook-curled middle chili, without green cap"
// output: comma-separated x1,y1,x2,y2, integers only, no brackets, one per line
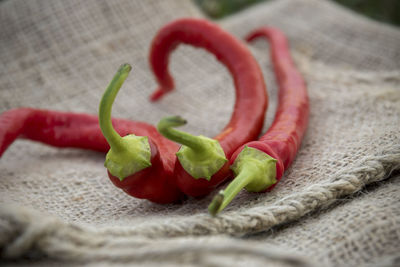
150,18,268,197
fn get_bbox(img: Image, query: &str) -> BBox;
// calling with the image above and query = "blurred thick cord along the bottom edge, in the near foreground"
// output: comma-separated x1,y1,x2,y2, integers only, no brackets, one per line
0,206,312,266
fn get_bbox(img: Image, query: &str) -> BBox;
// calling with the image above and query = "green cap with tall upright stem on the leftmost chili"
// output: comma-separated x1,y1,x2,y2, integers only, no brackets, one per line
99,64,151,181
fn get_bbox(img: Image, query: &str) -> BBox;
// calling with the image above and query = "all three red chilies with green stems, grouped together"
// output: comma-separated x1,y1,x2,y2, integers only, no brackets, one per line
0,18,309,215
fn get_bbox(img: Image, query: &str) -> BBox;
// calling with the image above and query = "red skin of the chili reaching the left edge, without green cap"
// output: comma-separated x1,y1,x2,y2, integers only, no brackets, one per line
0,108,183,203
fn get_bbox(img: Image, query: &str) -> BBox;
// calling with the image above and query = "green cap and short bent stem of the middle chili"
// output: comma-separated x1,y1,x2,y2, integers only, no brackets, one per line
157,116,228,181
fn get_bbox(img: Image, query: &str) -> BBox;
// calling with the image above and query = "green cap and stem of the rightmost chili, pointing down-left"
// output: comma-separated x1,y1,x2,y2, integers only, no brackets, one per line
208,146,277,216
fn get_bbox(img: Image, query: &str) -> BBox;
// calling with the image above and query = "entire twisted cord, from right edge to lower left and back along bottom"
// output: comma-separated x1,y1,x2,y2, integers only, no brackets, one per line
0,146,400,266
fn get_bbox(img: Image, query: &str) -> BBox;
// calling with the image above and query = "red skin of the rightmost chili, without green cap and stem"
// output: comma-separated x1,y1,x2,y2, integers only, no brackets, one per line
230,27,310,191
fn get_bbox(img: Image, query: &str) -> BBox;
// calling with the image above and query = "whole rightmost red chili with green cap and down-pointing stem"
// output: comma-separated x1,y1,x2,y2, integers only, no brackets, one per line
209,27,309,215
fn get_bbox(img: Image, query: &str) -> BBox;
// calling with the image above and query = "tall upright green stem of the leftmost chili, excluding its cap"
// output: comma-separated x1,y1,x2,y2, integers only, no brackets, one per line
99,64,132,151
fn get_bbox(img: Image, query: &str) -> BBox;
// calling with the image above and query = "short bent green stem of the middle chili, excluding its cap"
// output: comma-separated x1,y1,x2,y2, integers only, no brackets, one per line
157,116,205,152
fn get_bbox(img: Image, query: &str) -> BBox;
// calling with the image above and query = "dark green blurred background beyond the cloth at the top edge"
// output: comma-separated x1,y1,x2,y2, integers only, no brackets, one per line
194,0,400,26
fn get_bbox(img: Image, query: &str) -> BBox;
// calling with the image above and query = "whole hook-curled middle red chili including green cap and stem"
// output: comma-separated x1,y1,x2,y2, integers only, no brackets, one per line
150,18,268,197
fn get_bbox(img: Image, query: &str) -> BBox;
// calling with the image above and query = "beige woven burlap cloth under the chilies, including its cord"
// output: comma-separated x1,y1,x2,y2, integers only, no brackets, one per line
0,0,400,266
